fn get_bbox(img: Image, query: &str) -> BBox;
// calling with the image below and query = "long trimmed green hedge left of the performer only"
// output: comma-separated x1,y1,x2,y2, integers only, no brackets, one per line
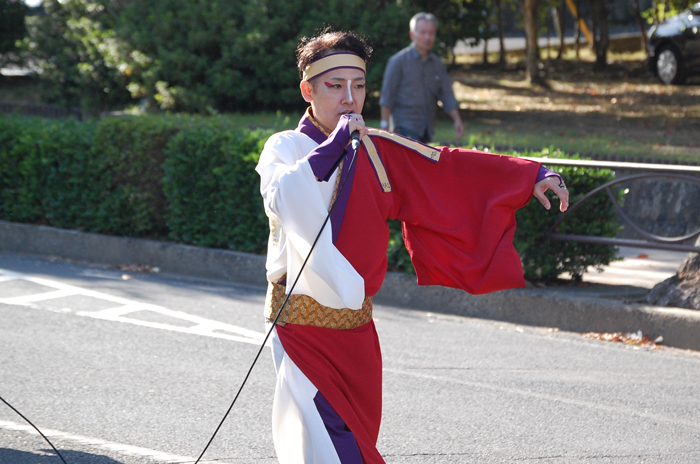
0,112,271,253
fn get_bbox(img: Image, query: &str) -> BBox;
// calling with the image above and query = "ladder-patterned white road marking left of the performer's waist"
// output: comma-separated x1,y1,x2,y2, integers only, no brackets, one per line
0,269,265,345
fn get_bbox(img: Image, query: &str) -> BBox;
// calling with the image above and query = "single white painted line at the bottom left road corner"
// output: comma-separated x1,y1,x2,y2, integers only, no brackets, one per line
0,420,235,464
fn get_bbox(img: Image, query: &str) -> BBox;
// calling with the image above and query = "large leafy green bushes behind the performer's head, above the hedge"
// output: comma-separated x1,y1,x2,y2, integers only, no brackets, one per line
24,0,413,112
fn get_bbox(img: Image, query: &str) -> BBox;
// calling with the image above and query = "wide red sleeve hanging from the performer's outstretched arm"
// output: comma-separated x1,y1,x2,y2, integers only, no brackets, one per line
383,146,540,294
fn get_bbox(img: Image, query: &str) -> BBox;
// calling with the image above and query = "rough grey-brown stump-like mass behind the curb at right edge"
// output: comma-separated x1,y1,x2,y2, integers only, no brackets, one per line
647,237,700,309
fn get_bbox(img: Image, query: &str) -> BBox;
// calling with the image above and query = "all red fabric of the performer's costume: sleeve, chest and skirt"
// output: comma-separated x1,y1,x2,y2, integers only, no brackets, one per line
277,131,540,464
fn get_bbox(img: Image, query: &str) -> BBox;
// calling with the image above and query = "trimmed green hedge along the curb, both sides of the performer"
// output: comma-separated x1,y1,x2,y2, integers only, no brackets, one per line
0,116,618,280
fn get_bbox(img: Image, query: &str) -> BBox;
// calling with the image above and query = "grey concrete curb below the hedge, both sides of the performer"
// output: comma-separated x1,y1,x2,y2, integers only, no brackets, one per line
0,221,700,351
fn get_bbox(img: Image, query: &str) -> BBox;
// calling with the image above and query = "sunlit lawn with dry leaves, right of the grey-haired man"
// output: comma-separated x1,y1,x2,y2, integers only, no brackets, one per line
435,49,700,162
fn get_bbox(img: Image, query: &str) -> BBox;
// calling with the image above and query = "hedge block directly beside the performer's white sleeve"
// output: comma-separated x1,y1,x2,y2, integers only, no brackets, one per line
163,127,270,253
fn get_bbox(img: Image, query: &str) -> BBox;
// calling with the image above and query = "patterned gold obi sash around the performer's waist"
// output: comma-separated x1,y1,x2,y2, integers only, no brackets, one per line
265,276,372,330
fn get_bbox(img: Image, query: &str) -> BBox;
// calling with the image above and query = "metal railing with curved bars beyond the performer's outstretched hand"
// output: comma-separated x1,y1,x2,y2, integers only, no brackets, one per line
526,158,700,253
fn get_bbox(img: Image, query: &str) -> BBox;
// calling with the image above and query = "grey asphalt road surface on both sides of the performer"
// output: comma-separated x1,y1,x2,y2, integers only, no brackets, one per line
0,253,700,464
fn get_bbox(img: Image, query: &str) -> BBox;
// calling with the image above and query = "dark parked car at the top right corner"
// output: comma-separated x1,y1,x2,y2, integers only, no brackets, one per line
647,3,700,84
